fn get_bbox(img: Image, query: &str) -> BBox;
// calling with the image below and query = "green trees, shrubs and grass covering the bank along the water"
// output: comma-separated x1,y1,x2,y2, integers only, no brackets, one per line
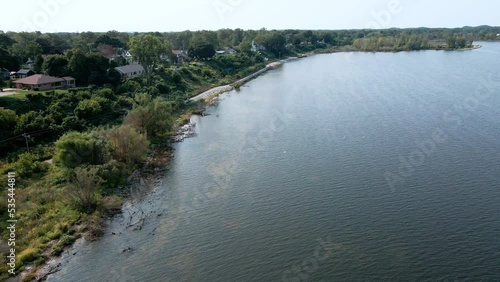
0,26,500,281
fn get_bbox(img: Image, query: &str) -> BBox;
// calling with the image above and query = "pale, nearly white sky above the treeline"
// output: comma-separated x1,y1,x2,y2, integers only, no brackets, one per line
0,0,500,32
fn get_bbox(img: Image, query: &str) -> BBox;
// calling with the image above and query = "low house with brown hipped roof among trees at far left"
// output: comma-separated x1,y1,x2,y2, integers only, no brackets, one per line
13,74,75,90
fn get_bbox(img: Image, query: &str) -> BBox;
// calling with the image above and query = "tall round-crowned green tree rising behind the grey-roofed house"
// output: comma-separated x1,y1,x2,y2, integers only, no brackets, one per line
129,34,172,86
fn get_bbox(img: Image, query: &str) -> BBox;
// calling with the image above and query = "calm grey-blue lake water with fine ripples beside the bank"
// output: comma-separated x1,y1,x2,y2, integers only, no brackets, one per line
48,43,500,281
